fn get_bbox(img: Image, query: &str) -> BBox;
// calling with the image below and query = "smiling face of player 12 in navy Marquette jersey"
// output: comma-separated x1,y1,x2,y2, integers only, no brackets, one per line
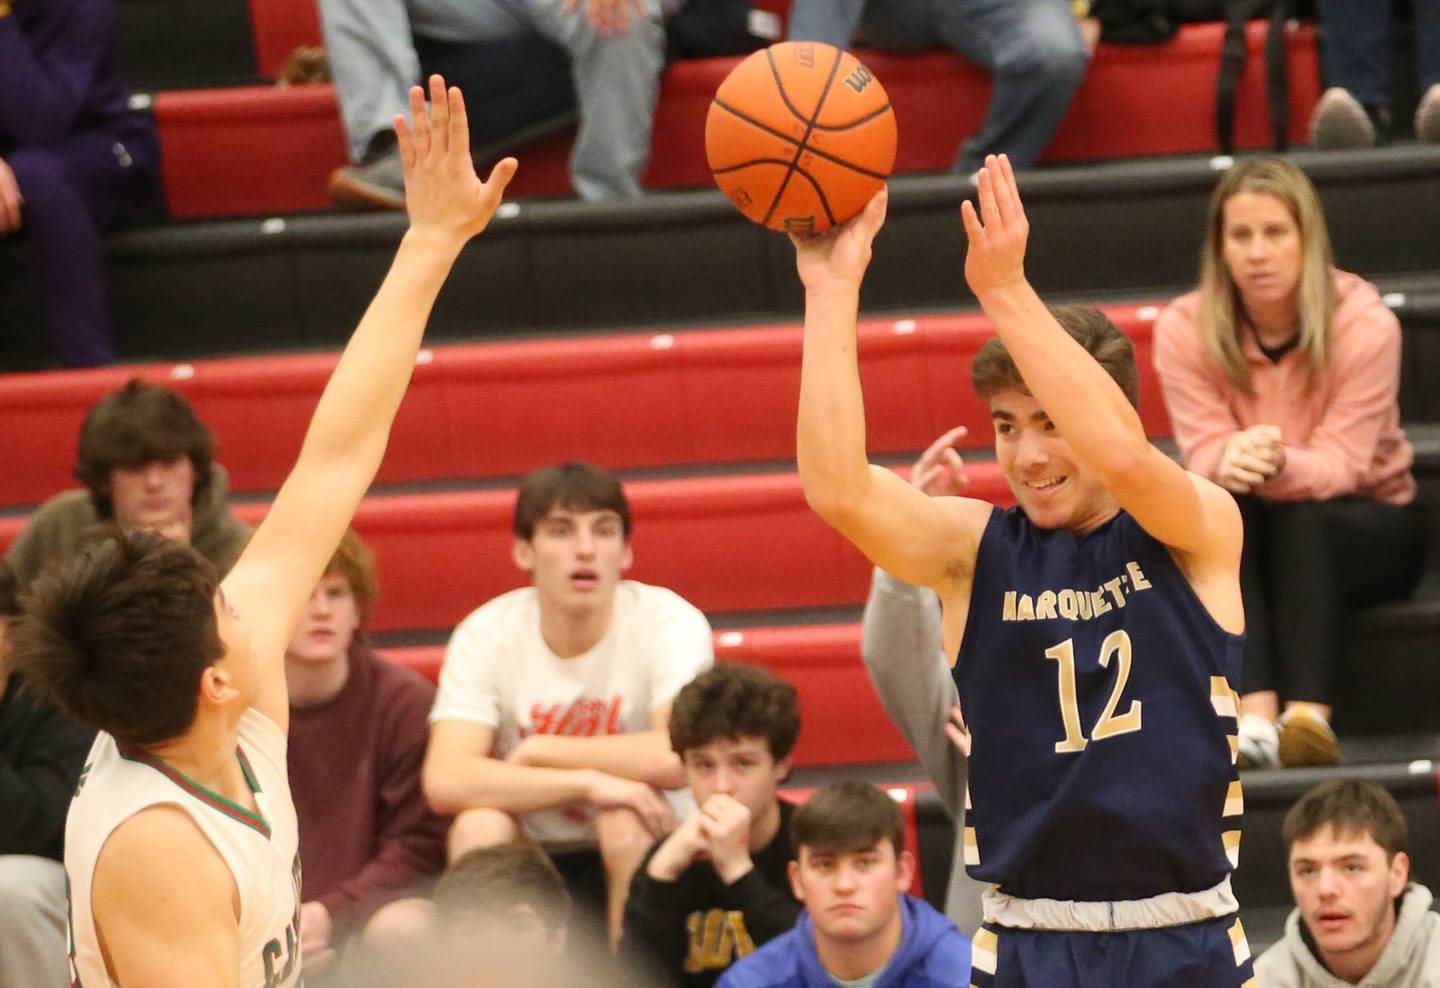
989,387,1117,531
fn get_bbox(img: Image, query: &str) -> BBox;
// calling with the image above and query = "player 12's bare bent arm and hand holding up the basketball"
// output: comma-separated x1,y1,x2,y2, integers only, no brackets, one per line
791,190,991,589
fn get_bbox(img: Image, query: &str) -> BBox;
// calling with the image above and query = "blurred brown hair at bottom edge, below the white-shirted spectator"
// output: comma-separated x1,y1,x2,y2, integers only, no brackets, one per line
433,844,570,930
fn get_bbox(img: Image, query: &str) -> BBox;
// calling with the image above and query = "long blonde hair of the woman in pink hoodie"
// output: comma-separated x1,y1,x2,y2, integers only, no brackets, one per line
1200,158,1335,393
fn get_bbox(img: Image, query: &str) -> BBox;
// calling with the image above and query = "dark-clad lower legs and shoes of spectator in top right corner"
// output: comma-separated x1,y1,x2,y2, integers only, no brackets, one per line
1310,0,1440,148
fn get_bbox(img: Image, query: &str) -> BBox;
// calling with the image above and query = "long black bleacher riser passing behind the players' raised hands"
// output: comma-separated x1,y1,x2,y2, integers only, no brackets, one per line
0,145,1440,367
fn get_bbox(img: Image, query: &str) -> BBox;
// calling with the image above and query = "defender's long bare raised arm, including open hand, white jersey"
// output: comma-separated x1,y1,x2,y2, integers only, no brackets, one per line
223,76,516,724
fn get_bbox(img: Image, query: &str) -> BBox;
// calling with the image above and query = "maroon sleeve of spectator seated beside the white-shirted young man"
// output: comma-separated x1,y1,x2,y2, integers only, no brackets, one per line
320,676,448,943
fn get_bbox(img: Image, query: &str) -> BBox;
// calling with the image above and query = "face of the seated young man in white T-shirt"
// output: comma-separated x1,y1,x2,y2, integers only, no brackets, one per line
516,507,631,609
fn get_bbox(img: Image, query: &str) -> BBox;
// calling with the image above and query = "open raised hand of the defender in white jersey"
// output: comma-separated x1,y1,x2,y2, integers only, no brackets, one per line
395,75,520,245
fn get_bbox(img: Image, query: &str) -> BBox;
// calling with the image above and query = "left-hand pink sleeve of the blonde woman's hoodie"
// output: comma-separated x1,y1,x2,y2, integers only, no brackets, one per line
1155,305,1240,480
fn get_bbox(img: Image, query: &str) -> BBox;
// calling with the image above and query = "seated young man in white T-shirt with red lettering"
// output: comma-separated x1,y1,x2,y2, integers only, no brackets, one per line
425,462,714,939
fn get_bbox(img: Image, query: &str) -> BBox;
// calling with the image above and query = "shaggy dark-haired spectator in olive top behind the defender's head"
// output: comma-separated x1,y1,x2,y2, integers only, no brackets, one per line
6,379,251,588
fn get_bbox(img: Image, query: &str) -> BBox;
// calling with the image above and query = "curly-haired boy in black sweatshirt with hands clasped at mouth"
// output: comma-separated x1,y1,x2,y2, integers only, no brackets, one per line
625,663,801,988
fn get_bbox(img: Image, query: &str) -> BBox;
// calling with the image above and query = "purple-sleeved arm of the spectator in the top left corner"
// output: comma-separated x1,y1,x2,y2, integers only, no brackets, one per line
0,0,115,145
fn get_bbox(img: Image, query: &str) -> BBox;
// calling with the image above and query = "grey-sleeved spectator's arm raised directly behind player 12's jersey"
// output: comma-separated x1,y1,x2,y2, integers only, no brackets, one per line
860,569,966,819
